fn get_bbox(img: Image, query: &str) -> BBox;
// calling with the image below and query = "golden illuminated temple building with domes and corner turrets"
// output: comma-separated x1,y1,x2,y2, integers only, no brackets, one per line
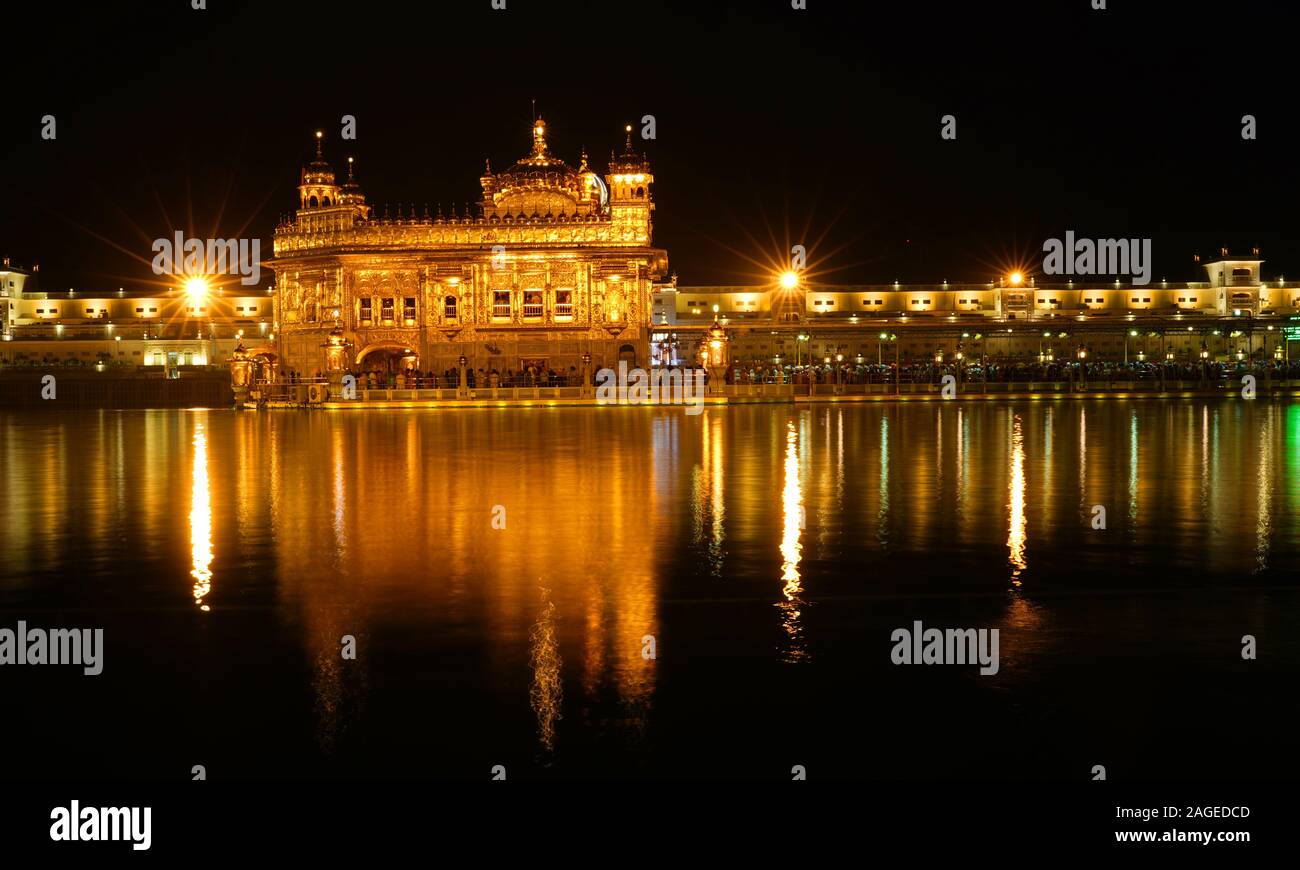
269,118,667,373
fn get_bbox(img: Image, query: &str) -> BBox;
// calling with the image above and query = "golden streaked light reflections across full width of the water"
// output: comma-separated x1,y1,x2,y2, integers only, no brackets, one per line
0,401,1300,775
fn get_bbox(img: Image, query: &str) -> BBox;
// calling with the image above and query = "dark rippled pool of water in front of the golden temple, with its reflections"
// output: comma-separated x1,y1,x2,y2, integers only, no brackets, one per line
0,399,1300,779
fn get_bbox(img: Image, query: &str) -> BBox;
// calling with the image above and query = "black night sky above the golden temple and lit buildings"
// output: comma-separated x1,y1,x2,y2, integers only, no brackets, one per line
0,0,1300,290
